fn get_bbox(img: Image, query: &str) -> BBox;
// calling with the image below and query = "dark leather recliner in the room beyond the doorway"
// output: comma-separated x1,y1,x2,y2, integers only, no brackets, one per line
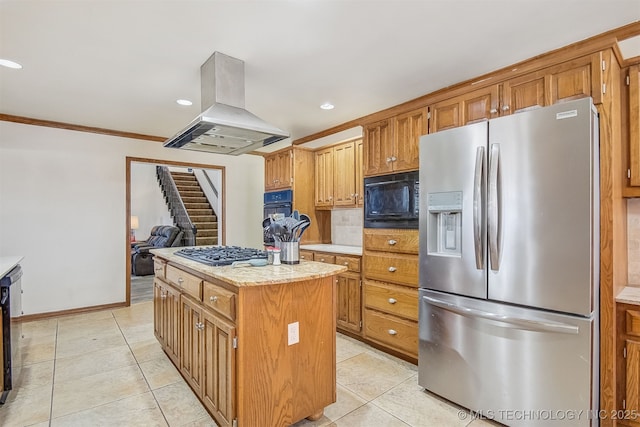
131,225,184,276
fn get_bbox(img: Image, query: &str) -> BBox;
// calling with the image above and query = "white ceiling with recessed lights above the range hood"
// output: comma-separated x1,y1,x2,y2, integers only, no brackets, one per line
0,0,640,151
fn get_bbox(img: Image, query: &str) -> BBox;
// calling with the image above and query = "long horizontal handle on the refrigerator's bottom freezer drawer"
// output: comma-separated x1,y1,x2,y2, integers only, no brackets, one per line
422,296,579,335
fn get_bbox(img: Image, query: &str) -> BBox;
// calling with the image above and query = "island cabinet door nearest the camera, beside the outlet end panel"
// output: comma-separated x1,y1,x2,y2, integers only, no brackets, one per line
202,310,236,427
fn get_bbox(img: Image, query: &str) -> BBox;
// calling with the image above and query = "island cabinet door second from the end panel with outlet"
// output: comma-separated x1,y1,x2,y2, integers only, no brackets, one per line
180,295,204,396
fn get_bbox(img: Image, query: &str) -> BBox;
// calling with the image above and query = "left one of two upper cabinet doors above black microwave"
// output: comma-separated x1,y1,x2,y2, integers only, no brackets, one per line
363,119,393,176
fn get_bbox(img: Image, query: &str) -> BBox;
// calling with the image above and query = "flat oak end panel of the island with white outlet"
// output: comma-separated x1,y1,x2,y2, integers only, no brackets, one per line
238,277,336,426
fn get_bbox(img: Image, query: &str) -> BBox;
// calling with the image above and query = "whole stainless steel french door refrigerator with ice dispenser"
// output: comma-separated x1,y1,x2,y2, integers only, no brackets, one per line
418,98,599,426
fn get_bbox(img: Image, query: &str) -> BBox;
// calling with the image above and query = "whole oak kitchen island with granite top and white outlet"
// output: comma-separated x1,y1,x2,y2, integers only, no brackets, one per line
151,248,346,427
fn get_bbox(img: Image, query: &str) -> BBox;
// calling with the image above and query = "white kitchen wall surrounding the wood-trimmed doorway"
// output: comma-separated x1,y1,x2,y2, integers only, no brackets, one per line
0,122,264,315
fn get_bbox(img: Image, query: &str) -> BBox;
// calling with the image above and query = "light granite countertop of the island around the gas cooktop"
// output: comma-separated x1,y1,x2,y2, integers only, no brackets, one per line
151,248,347,287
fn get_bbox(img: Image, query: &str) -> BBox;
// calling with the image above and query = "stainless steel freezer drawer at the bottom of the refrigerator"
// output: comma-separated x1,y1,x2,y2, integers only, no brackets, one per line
418,289,599,426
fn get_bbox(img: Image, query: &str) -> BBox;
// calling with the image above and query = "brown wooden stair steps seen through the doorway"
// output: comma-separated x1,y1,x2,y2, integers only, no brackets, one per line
171,172,218,246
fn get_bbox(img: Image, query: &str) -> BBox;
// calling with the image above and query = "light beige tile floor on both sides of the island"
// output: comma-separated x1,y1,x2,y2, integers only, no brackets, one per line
0,302,498,427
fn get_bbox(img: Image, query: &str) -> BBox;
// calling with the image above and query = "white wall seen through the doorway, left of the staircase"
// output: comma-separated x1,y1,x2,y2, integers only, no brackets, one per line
131,162,174,240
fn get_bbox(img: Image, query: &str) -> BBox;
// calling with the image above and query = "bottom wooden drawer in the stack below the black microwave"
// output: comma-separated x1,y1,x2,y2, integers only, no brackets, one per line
364,309,418,357
